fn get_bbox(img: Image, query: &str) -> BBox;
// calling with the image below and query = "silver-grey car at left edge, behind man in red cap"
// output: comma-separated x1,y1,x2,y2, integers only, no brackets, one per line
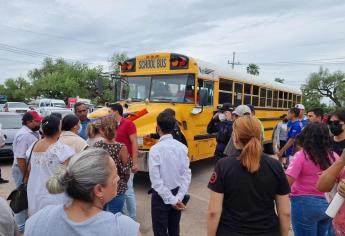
0,112,22,158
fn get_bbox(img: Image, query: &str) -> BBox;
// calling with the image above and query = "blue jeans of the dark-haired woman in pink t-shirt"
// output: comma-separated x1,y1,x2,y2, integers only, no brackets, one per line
290,196,334,236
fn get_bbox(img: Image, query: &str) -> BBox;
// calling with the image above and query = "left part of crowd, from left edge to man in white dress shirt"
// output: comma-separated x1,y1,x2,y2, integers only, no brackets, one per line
0,103,191,236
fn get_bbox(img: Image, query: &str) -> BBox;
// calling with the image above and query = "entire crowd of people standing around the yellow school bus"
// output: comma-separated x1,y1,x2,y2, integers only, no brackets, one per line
0,100,345,236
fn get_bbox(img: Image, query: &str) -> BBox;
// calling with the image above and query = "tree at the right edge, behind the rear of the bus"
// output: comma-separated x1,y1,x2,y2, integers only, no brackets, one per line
302,67,345,107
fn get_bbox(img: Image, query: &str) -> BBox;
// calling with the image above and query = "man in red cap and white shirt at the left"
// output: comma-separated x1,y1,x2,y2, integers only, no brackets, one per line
12,111,43,232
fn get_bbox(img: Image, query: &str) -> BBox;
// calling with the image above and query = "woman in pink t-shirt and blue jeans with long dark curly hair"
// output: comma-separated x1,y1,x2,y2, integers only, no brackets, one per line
285,123,338,236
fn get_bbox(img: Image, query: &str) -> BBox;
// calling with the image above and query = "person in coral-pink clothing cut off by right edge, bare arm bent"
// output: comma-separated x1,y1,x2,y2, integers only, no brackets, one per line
317,149,345,236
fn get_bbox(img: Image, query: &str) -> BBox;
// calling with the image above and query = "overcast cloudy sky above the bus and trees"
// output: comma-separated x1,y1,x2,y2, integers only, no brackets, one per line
0,0,345,87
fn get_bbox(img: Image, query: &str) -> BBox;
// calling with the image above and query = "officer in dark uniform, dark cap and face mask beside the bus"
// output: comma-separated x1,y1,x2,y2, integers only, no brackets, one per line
207,103,234,162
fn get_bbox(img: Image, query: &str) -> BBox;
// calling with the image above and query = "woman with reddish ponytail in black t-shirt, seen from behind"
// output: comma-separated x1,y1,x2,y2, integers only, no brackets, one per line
208,116,290,236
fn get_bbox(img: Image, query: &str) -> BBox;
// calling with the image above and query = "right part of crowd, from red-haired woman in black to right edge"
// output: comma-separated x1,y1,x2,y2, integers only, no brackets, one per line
208,104,345,236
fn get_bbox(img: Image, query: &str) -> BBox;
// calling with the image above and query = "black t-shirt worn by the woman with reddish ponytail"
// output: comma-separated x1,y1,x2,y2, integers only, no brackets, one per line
208,151,290,236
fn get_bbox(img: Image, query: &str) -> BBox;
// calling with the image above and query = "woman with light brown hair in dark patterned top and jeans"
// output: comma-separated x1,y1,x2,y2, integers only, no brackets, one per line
94,116,132,214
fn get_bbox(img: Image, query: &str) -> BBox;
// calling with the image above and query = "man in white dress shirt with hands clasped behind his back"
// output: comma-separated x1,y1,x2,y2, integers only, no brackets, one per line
149,112,192,236
